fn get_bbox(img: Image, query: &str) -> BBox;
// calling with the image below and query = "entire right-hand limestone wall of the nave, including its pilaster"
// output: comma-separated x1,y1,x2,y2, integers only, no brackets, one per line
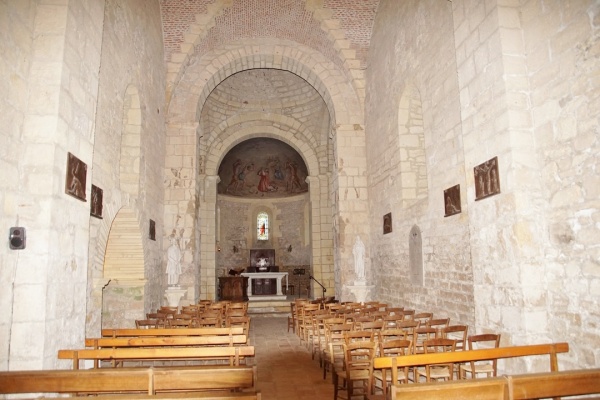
366,0,600,371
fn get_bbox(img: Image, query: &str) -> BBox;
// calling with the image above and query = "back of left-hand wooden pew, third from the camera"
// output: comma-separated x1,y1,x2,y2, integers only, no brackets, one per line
85,335,248,349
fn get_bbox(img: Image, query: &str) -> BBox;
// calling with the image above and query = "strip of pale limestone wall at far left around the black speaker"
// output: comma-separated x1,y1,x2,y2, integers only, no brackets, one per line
0,1,36,370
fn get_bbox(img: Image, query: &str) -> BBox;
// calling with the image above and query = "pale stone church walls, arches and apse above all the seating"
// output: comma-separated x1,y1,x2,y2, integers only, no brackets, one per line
0,0,600,384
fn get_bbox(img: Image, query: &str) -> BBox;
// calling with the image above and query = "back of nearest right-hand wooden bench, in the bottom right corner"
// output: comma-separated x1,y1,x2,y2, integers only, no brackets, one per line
391,369,600,400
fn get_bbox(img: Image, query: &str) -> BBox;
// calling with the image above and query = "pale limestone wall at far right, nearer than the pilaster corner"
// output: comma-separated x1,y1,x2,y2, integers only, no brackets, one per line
520,1,600,368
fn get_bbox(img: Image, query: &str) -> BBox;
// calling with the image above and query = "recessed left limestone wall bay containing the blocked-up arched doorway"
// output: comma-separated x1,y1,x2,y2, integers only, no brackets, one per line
87,1,169,335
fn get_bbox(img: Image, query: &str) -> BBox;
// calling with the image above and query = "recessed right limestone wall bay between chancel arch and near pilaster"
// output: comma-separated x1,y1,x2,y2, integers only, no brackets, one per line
365,1,475,325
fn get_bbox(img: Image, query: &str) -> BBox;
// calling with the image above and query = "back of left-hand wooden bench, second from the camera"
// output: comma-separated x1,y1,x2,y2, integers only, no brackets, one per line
58,346,254,369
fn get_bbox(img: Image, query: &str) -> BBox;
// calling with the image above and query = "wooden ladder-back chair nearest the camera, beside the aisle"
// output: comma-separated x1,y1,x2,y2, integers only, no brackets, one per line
333,341,377,400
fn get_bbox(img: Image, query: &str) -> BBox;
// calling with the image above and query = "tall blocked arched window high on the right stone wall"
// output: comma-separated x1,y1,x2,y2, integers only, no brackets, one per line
398,83,428,207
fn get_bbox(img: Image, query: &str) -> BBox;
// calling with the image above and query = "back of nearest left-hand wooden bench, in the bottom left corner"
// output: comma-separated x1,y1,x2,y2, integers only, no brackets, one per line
0,366,256,395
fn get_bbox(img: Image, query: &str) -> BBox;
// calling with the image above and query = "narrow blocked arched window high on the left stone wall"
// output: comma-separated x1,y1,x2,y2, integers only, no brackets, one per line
119,85,142,196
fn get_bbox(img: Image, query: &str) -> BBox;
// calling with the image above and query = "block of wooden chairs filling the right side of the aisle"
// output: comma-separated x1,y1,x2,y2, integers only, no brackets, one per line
288,302,500,398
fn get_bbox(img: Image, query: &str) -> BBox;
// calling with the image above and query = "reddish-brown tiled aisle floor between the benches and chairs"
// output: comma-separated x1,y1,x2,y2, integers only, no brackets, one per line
250,316,332,400
